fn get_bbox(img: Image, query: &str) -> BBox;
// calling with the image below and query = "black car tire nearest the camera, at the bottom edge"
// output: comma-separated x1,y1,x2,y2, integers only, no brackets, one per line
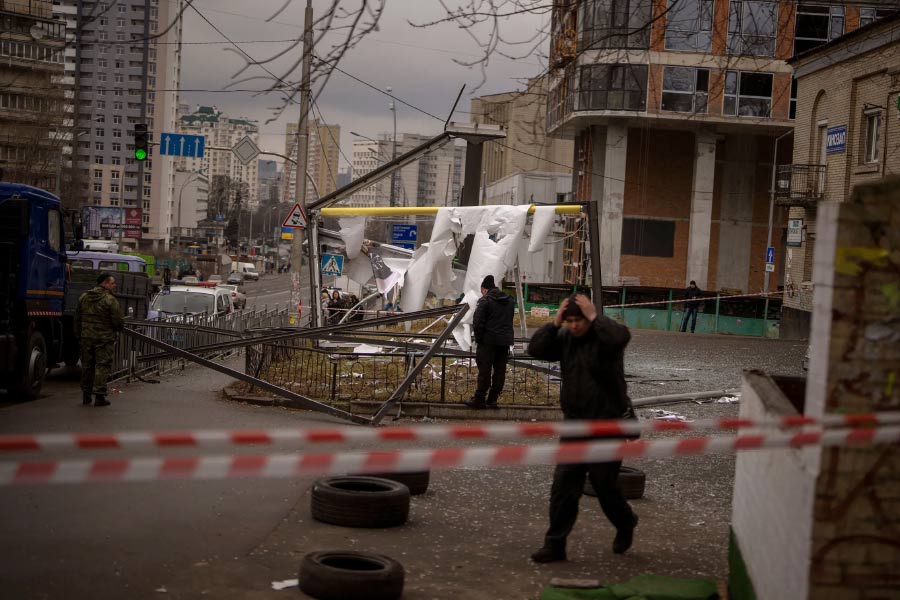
298,550,404,600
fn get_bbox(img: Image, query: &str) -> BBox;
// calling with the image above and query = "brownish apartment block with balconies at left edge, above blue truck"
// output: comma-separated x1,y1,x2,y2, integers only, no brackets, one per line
0,0,71,192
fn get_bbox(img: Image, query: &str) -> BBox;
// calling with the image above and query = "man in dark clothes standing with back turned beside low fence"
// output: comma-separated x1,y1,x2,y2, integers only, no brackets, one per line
465,275,515,408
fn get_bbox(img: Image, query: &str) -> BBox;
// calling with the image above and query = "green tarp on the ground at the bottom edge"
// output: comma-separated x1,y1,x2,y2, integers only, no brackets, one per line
540,575,719,600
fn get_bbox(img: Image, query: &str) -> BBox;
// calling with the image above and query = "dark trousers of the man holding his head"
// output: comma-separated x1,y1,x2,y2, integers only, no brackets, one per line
544,462,634,548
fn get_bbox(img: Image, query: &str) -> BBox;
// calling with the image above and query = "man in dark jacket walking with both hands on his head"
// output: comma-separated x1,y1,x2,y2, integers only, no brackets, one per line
528,294,638,563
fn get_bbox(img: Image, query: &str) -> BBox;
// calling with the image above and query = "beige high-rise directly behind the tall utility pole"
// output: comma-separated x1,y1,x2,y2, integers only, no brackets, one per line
283,119,341,202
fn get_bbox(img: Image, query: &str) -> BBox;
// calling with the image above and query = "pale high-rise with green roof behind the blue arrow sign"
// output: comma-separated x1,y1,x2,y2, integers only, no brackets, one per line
177,106,259,210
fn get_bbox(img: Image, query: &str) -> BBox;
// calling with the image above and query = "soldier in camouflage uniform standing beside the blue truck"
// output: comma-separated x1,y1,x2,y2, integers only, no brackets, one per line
75,273,125,406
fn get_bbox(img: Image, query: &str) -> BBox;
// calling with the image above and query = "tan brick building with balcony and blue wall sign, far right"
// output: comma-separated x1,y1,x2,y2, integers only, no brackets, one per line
776,15,900,337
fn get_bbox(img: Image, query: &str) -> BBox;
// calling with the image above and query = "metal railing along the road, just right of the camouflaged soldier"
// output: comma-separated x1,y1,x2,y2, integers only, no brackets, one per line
110,306,290,380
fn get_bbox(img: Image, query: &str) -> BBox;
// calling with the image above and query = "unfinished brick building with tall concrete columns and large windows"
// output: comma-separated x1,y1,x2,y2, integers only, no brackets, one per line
547,0,892,292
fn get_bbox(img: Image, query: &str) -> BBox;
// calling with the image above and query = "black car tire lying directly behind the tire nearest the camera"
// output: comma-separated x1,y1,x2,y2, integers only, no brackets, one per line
310,475,410,528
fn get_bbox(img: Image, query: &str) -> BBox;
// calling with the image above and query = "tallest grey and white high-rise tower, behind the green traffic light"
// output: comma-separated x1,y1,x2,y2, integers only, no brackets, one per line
54,0,183,251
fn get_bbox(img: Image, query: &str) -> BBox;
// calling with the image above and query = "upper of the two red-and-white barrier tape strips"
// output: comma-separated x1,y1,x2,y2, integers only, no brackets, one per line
0,412,900,455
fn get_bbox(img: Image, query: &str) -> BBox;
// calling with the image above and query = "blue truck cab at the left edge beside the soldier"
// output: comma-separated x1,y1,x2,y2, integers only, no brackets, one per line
0,183,67,397
